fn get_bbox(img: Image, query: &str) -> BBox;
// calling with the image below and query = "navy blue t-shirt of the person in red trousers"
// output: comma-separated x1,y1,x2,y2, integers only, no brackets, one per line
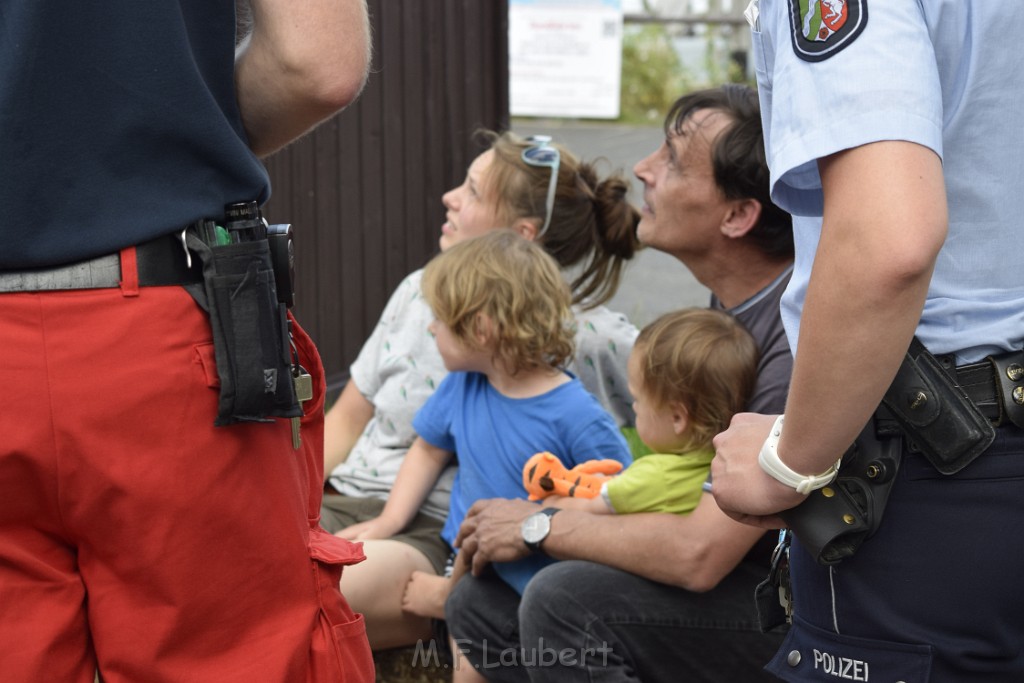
0,0,269,269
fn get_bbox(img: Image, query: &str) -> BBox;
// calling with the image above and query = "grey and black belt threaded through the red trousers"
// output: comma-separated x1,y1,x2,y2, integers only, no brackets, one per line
0,233,203,292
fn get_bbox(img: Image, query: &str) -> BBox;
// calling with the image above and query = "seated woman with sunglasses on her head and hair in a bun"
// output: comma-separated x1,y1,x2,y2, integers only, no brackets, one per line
322,133,639,649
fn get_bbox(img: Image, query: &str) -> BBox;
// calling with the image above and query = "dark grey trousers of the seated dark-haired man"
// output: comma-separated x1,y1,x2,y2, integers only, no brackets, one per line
446,561,782,683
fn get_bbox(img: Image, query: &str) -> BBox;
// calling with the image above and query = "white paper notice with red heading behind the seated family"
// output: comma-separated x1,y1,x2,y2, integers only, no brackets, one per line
509,0,623,119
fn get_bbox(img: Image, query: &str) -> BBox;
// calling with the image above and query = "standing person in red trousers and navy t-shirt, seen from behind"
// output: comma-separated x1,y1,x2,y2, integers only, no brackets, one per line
0,0,373,683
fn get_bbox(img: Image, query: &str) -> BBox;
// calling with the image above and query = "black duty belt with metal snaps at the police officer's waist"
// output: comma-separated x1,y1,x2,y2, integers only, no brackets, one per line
936,351,1024,427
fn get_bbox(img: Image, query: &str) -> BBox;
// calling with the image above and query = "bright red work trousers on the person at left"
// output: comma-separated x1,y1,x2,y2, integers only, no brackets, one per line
0,254,374,683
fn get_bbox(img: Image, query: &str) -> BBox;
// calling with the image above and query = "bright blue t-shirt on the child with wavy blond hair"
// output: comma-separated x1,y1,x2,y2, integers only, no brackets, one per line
413,373,631,593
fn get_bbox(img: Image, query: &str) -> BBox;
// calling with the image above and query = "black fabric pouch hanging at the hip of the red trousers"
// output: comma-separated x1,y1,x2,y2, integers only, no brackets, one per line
187,231,302,427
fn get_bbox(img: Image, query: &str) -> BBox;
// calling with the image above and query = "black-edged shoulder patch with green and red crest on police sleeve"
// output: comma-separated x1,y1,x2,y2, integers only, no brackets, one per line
790,0,867,61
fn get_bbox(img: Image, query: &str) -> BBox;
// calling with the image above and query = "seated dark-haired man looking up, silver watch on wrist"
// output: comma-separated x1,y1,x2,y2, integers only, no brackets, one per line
446,86,793,683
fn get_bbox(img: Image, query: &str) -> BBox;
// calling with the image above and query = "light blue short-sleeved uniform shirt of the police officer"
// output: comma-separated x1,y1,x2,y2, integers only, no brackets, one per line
754,0,1024,362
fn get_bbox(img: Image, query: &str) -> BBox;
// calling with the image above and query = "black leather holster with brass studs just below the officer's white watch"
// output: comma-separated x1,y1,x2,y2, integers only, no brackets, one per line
780,418,902,564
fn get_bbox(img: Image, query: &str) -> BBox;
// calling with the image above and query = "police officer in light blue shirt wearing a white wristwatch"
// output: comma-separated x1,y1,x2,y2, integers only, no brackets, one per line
713,0,1024,683
